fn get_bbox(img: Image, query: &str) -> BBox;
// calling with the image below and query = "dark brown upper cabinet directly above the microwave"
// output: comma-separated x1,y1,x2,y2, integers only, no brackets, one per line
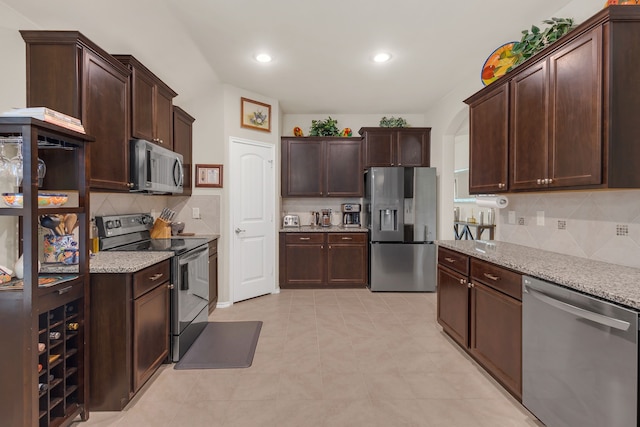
113,55,177,150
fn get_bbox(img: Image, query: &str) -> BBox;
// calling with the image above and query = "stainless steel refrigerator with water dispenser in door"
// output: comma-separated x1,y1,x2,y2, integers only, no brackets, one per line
364,167,437,292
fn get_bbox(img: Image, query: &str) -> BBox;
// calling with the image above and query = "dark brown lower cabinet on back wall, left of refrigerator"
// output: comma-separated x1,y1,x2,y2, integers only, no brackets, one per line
280,232,369,288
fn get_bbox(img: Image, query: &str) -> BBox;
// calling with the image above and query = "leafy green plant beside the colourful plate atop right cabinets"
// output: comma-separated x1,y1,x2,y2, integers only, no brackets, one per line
507,18,575,71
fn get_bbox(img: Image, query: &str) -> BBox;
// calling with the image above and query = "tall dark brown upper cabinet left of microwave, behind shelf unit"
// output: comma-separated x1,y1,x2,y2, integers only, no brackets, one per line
20,31,130,191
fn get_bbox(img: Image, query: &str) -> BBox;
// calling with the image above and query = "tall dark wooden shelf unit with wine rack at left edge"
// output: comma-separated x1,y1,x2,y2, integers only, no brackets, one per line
0,117,93,427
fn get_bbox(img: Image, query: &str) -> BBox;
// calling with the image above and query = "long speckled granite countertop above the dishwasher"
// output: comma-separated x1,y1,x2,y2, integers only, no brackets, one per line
437,240,640,310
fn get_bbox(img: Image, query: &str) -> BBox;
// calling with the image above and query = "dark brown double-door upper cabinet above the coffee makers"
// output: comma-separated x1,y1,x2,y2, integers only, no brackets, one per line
281,137,363,197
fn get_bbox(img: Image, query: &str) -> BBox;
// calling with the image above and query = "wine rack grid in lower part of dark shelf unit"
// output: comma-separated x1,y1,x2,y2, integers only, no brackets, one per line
38,299,84,427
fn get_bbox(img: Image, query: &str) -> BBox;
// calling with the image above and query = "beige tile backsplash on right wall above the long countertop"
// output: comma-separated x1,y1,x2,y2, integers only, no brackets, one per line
492,190,640,268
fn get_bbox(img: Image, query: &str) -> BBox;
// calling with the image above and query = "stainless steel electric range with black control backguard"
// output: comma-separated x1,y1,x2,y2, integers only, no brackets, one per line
96,214,209,362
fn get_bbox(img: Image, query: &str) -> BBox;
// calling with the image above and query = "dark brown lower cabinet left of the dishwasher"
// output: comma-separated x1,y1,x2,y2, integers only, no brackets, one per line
438,248,522,400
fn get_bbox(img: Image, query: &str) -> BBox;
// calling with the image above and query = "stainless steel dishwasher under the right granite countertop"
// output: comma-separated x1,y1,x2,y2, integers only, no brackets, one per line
522,276,638,427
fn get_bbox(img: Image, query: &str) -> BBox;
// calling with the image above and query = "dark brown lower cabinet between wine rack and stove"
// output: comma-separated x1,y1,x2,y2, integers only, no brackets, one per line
89,260,170,411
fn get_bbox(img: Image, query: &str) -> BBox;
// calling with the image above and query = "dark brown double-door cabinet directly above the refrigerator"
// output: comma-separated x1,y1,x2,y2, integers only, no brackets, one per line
359,127,431,168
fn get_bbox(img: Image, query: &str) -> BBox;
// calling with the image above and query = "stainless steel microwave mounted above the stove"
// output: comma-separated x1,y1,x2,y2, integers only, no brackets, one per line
129,139,184,194
